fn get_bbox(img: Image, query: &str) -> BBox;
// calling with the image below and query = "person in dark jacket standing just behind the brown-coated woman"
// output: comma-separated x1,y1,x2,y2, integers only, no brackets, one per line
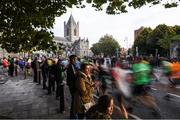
66,55,77,119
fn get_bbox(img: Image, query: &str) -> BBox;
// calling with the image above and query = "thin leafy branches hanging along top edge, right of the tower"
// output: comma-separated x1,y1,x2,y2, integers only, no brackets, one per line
86,0,179,14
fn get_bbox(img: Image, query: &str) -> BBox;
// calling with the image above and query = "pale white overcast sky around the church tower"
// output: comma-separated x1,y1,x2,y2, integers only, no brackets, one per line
52,5,180,48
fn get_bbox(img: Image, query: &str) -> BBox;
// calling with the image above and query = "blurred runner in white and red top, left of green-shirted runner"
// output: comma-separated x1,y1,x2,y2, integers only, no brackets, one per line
111,67,132,119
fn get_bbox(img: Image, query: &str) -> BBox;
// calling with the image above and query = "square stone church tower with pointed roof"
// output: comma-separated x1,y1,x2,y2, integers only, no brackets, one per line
64,14,79,42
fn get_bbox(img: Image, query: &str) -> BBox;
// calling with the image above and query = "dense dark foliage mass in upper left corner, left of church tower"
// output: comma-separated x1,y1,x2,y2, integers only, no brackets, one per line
0,0,68,53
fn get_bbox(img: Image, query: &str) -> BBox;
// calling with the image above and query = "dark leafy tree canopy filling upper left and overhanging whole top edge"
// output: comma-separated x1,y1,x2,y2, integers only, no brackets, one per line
0,0,179,52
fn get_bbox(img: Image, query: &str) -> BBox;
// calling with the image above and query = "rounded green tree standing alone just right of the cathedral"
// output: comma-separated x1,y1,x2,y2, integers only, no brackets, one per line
91,35,120,56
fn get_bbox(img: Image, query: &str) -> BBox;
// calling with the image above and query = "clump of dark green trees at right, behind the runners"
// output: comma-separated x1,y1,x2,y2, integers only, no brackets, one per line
133,24,177,56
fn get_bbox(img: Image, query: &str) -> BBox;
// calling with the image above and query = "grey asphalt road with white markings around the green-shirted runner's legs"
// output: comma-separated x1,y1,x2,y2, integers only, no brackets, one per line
121,69,180,119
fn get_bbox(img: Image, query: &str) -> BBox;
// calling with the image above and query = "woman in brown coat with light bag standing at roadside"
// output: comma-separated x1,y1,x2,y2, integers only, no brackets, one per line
73,63,95,119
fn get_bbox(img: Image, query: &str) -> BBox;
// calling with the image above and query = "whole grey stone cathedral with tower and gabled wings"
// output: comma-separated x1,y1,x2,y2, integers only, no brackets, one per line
54,14,89,57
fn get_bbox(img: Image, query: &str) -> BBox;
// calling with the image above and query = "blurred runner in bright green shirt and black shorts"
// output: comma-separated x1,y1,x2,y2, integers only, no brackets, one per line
132,58,161,116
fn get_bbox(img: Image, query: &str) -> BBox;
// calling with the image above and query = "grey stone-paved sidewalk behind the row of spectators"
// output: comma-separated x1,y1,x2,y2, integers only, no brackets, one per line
0,76,71,119
